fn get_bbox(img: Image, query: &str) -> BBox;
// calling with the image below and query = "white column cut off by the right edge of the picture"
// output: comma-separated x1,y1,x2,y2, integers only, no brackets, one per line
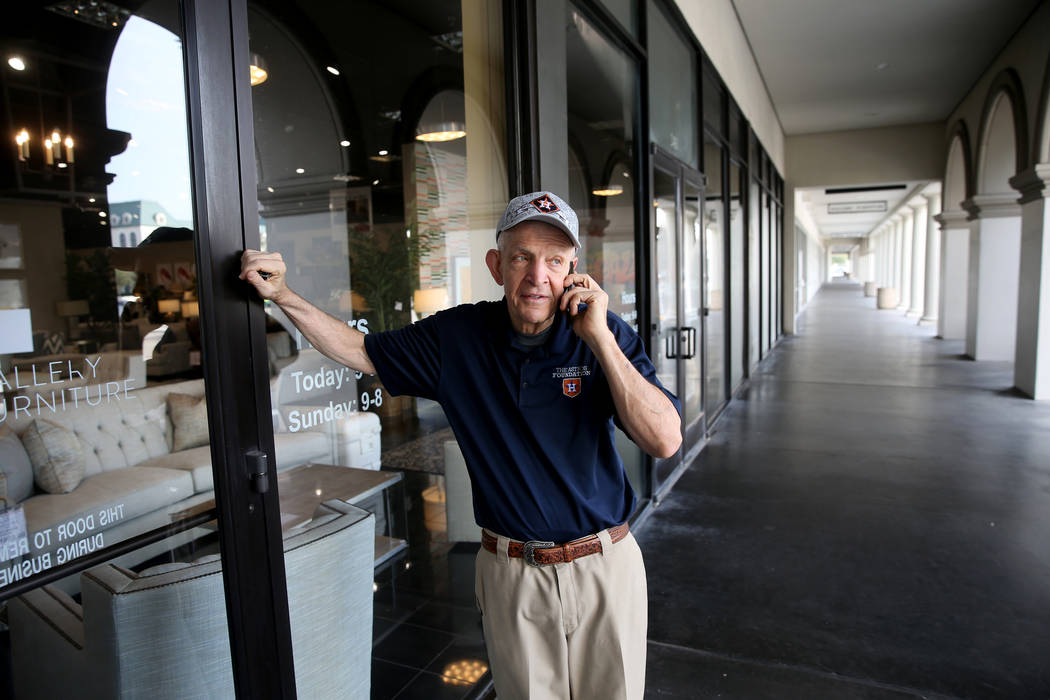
1010,163,1050,400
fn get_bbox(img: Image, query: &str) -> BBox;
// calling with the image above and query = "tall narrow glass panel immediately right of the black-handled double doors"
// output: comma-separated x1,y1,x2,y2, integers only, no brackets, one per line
704,141,726,417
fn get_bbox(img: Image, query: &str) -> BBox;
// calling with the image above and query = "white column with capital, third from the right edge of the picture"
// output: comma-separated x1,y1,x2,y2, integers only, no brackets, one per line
936,209,970,340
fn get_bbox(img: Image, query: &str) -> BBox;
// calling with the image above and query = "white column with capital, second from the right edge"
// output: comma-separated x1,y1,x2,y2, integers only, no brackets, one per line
963,192,1021,362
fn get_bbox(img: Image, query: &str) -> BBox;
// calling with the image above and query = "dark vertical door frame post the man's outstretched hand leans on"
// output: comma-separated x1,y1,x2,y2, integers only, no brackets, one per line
181,0,295,698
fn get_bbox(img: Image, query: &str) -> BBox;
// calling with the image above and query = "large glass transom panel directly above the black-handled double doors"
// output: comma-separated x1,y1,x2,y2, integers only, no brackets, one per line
649,1,699,168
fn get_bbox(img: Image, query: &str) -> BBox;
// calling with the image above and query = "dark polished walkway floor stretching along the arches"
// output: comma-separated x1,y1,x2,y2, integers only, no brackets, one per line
637,284,1050,700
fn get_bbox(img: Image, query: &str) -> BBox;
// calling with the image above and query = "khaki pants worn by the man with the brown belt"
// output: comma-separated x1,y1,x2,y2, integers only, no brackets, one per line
475,531,648,700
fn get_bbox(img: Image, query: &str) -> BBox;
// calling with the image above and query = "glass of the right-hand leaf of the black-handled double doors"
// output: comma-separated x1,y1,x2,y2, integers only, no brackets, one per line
679,182,704,434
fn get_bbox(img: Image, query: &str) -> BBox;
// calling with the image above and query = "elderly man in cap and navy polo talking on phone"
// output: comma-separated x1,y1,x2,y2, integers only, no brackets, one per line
240,192,681,700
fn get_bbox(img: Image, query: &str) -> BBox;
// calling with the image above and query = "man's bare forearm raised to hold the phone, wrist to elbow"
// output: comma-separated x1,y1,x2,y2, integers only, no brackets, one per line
592,332,681,458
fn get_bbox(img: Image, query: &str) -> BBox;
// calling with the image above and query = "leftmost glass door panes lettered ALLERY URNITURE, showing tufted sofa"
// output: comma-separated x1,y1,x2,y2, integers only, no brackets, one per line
0,0,240,698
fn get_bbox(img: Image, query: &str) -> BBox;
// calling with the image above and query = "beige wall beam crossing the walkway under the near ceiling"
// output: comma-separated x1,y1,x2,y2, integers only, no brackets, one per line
785,122,947,187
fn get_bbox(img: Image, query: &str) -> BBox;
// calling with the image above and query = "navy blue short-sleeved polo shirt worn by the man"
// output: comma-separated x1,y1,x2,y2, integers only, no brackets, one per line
364,300,681,543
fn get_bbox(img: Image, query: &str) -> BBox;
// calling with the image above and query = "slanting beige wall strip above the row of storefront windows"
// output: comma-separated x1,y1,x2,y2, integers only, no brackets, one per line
677,0,784,173
